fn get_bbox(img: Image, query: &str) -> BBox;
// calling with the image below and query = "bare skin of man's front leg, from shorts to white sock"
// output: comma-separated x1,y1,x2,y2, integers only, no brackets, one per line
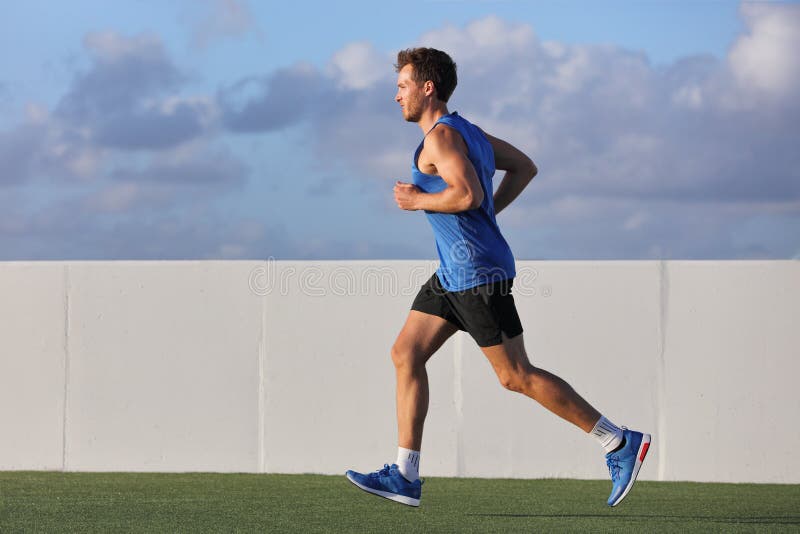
392,310,458,451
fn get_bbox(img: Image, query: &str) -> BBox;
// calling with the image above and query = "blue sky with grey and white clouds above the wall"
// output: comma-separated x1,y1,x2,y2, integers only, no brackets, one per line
0,0,800,259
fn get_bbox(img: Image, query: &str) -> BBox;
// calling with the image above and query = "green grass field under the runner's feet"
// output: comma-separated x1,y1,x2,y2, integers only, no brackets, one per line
0,472,800,534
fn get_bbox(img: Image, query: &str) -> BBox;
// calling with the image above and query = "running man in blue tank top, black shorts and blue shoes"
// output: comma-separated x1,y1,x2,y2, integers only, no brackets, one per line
347,48,650,506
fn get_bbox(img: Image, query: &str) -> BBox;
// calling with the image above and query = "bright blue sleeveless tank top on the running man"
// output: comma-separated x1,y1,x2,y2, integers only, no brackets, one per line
411,112,516,291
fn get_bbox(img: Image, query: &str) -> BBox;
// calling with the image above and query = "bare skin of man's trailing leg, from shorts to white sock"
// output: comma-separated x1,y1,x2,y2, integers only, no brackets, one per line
481,334,600,432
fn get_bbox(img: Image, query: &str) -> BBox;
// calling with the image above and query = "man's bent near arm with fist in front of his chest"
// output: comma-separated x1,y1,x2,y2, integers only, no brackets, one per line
394,125,483,213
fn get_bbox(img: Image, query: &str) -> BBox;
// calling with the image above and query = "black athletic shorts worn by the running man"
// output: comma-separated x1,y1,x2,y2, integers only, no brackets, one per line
411,273,522,347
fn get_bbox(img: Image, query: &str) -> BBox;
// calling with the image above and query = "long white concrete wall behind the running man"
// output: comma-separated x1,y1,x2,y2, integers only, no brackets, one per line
0,261,800,483
